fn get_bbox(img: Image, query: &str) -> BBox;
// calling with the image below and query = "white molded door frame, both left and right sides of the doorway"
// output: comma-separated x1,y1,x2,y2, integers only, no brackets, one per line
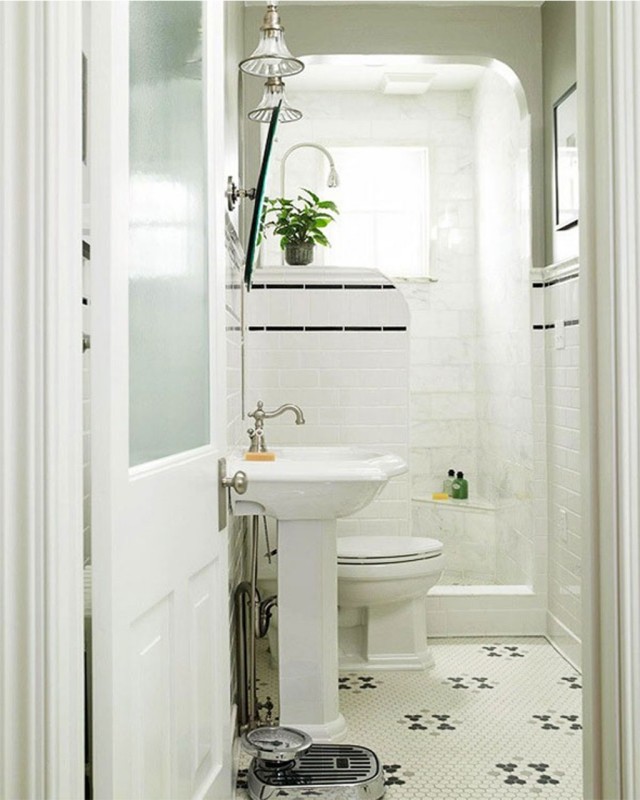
0,0,640,800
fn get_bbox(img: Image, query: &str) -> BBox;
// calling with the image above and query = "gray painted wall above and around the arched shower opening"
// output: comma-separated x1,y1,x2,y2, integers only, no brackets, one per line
244,2,544,266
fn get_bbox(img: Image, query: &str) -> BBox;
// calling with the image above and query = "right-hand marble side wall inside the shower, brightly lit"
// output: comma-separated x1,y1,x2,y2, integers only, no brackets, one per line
473,70,542,585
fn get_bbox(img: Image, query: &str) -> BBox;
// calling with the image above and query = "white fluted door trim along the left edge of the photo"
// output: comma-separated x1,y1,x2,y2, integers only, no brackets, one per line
0,2,84,800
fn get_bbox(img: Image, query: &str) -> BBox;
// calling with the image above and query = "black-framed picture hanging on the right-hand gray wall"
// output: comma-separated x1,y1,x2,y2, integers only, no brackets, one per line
553,83,579,231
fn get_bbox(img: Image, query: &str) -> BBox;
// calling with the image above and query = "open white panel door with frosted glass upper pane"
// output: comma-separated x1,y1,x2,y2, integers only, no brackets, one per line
86,0,231,800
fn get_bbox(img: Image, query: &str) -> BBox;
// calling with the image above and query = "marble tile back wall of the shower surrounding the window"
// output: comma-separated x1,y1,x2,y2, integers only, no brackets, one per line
262,87,478,495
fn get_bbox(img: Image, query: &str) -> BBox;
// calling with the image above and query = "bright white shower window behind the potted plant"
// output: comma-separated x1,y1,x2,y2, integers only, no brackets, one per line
319,146,430,278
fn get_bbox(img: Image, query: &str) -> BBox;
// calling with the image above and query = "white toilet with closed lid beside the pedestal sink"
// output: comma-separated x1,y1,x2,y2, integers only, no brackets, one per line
338,536,444,670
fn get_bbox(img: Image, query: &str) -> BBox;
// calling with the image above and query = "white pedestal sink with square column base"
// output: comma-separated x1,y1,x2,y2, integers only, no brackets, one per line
227,447,407,742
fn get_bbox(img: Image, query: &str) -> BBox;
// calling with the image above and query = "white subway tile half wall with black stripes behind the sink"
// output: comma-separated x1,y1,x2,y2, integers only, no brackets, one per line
246,267,411,536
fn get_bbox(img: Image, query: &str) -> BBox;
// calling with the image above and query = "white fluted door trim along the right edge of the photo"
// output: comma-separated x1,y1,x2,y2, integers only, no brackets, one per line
577,0,640,800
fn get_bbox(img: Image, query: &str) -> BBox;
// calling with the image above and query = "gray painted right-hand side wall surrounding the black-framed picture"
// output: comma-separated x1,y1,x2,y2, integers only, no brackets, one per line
542,0,578,264
